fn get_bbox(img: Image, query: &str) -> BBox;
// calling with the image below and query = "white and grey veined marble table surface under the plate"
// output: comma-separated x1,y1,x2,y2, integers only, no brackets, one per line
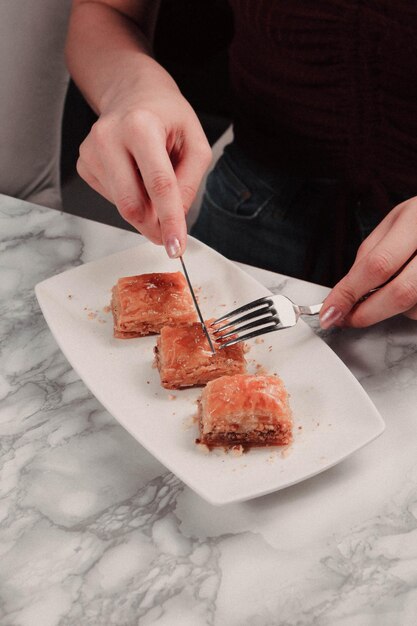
0,191,417,626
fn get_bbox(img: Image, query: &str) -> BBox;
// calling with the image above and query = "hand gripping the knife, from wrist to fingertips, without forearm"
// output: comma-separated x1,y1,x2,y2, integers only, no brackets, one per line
77,58,211,258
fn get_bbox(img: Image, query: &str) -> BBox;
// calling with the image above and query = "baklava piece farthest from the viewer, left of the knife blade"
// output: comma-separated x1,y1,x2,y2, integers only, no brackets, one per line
111,272,196,339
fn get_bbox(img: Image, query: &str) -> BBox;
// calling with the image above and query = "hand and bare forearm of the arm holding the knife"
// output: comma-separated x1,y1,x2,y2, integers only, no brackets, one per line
66,0,211,257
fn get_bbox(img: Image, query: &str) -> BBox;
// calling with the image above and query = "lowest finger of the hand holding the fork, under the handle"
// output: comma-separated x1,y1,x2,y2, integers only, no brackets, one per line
345,257,417,328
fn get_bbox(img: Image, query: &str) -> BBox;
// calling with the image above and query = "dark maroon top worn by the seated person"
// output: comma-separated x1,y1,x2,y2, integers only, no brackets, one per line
230,0,417,193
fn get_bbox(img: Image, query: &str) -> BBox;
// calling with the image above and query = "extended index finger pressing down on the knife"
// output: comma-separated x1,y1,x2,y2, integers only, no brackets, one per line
133,131,187,258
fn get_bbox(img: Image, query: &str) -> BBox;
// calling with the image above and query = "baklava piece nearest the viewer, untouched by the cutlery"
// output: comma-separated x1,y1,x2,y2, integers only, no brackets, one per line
197,374,292,448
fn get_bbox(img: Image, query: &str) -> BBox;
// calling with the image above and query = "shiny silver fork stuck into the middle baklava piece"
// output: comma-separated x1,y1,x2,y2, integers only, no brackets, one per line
210,294,323,349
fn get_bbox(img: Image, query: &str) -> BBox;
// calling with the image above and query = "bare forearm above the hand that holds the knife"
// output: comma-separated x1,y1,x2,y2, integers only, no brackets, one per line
66,0,175,113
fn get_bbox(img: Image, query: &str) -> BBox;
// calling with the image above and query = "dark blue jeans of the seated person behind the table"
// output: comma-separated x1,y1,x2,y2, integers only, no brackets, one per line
191,143,412,286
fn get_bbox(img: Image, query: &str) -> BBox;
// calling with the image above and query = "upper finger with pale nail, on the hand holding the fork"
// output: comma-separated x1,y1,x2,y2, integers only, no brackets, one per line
320,211,416,328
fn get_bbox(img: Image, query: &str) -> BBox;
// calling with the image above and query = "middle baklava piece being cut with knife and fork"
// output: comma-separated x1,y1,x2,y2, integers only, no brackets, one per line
155,322,246,389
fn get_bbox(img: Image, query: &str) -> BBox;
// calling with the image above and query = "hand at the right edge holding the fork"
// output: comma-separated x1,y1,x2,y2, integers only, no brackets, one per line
320,197,417,328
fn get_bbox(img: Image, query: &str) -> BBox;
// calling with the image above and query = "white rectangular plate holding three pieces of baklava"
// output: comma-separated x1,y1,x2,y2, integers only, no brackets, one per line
36,237,384,504
